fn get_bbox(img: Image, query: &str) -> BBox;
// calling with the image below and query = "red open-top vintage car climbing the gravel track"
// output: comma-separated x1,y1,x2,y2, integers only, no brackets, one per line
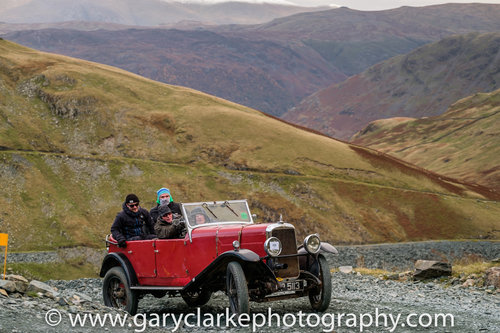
100,200,337,314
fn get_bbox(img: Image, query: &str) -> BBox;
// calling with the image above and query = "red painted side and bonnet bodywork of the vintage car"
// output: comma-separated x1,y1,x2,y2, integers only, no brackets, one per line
108,224,270,287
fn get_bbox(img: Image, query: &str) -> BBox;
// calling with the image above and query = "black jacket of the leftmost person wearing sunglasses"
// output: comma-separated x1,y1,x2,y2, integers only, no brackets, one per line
111,203,154,243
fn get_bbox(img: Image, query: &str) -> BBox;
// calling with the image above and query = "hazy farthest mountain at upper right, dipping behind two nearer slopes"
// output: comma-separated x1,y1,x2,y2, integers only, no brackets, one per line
229,3,500,76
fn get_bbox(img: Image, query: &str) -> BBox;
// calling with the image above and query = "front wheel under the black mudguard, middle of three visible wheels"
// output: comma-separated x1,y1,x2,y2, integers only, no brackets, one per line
226,261,249,315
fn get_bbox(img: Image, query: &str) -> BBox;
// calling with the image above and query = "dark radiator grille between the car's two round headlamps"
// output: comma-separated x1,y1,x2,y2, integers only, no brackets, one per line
271,228,300,278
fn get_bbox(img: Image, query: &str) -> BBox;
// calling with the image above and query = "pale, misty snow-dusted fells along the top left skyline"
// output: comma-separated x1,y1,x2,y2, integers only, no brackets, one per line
0,0,328,26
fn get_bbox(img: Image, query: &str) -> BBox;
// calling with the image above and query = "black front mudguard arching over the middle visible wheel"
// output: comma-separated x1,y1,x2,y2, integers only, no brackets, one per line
183,249,276,291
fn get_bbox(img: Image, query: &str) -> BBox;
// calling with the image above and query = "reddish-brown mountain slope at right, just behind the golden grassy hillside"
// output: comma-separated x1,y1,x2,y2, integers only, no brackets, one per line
283,33,500,139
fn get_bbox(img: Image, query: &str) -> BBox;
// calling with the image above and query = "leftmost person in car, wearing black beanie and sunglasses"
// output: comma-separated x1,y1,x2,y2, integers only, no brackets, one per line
111,193,156,247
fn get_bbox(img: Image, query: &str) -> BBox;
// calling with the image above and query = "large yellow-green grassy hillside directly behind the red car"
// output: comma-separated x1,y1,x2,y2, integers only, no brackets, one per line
0,40,500,250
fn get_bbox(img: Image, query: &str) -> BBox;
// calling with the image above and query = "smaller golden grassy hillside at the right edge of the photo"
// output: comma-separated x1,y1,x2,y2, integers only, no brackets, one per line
353,90,500,193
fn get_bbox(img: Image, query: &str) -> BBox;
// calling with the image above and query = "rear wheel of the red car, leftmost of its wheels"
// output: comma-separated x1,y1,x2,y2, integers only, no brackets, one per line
102,266,139,315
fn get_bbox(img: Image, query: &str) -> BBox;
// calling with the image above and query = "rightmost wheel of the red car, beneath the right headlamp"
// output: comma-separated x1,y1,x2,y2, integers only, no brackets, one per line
309,254,332,312
